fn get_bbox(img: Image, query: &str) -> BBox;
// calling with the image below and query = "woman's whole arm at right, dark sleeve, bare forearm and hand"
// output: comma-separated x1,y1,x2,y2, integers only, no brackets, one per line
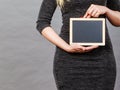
84,0,120,26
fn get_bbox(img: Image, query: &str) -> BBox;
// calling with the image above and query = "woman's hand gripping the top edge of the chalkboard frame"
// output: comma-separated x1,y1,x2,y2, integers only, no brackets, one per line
83,4,108,18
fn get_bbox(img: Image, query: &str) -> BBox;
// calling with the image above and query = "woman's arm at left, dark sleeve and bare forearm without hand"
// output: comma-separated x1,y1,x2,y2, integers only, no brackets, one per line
37,0,70,51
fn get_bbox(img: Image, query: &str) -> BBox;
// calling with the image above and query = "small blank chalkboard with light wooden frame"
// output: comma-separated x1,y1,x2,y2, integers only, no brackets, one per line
70,18,105,46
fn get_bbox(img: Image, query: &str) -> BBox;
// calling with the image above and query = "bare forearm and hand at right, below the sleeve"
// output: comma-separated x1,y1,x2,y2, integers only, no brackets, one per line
84,4,120,26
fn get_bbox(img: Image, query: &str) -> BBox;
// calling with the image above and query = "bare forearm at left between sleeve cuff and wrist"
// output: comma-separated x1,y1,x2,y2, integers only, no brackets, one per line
42,27,69,51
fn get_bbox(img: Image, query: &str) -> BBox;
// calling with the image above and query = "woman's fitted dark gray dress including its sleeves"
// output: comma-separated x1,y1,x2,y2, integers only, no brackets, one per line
37,0,120,90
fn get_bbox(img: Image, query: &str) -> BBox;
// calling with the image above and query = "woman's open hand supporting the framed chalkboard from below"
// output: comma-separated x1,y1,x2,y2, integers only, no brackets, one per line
66,44,98,53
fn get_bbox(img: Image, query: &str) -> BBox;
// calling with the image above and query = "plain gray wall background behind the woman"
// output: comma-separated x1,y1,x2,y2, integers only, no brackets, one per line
0,0,120,90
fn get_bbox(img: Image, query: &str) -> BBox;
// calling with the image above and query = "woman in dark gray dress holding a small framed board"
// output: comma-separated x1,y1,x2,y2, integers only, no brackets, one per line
37,0,120,90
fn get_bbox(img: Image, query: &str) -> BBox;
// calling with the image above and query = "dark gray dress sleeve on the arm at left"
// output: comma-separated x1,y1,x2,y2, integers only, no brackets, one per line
36,0,57,33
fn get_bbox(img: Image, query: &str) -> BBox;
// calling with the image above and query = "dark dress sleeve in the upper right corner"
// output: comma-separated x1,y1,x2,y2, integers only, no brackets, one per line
107,0,120,11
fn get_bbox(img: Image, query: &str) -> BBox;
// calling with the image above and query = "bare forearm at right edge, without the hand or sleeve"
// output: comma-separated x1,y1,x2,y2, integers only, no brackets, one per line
106,8,120,26
